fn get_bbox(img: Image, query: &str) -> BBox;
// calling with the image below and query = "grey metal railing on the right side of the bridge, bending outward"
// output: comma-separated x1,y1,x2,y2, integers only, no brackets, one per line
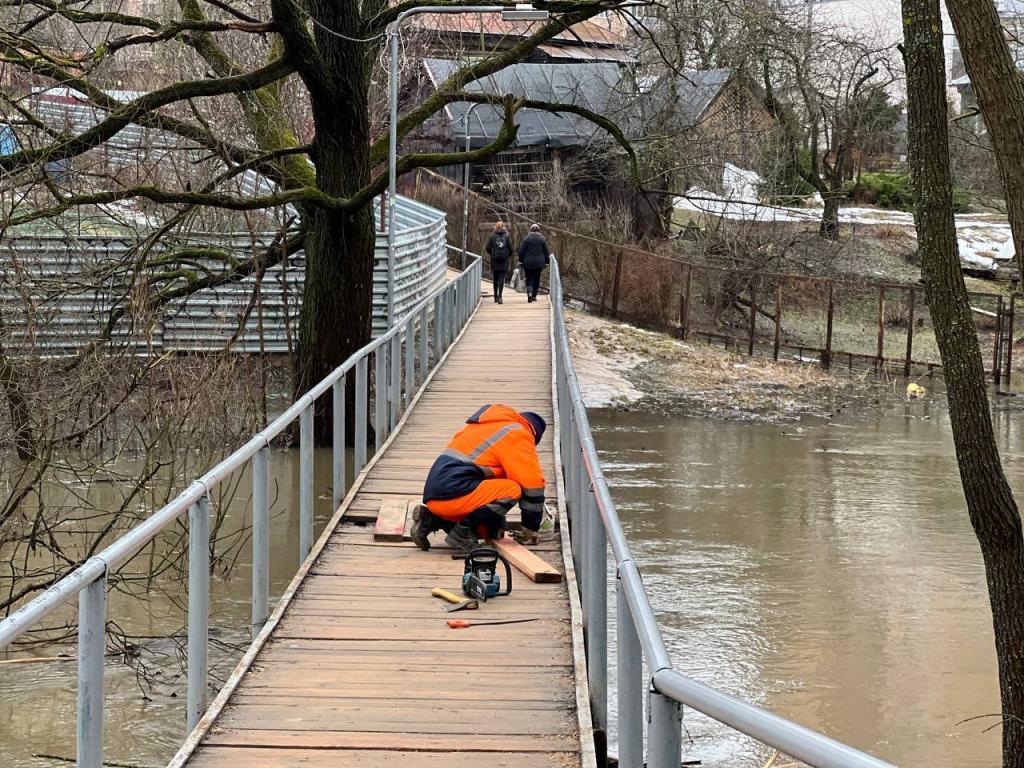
551,257,891,768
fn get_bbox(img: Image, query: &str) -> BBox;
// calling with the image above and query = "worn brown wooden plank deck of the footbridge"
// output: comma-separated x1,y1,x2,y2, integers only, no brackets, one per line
187,291,589,768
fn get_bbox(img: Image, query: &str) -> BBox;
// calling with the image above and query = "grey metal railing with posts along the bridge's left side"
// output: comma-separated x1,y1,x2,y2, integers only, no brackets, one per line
0,256,482,768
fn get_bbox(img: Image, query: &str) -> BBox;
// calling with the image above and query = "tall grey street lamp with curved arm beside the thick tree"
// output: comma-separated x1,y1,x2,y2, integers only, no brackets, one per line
387,3,549,328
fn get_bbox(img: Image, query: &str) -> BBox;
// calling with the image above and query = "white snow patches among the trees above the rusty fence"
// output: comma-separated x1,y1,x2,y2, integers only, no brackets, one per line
675,165,1014,271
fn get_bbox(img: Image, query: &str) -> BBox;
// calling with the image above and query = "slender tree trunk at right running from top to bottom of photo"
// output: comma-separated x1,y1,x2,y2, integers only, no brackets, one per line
902,0,1024,768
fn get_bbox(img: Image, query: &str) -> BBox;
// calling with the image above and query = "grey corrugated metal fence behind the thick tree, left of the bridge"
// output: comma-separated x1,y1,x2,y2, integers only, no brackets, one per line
0,198,446,356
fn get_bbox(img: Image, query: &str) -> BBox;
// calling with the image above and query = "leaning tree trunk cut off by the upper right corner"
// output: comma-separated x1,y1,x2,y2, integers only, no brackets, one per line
946,0,1024,269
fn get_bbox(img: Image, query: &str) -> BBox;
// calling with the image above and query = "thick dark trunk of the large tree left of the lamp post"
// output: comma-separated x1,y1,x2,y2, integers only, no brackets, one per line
295,64,376,444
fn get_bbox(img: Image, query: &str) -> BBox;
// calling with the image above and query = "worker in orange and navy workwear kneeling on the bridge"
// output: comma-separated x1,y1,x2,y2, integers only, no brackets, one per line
412,406,546,552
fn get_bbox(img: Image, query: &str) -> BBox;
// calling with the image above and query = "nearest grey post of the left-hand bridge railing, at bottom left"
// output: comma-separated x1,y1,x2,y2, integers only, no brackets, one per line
77,573,106,768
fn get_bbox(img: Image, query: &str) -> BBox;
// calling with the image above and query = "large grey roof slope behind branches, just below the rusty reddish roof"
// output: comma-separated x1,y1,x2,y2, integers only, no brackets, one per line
423,58,621,146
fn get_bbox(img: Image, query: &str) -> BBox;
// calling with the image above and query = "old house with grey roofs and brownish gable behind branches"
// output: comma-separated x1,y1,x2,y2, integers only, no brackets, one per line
414,58,772,224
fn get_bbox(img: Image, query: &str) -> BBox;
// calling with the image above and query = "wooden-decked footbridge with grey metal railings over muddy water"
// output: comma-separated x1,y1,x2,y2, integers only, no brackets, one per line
0,252,888,768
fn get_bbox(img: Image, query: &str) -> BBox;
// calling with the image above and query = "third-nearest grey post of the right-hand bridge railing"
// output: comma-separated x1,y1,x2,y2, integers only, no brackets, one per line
586,488,608,731
